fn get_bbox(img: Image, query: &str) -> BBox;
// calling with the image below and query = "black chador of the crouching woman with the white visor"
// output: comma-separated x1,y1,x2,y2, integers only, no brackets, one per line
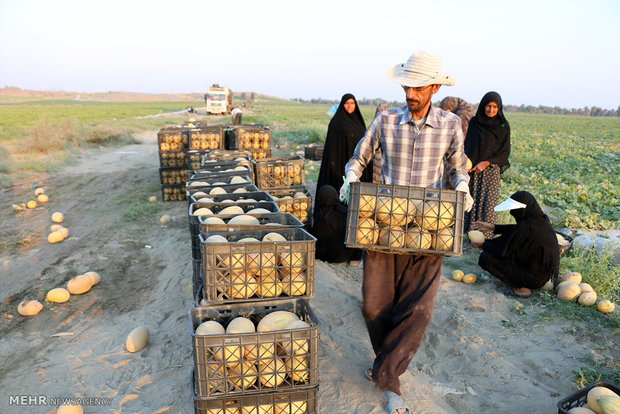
482,191,560,288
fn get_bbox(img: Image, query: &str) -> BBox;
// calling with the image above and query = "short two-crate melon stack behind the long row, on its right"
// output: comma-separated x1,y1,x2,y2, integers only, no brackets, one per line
254,155,312,228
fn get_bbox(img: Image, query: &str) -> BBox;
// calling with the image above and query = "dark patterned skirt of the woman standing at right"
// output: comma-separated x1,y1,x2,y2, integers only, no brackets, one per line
463,164,501,239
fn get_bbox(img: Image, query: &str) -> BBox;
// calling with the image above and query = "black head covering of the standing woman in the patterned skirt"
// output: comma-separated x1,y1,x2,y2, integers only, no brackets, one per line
465,92,510,172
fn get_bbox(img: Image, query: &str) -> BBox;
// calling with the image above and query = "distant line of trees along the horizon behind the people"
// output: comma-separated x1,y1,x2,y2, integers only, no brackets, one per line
291,98,620,117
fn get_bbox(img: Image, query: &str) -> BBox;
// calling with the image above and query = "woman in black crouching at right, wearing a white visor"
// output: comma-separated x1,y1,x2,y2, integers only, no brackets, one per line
471,191,560,296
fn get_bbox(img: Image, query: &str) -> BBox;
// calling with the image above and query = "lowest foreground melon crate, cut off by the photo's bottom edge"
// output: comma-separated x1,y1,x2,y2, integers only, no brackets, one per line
191,370,319,414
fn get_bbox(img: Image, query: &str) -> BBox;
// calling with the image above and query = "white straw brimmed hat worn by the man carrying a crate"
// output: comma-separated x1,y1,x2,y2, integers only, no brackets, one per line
388,51,454,88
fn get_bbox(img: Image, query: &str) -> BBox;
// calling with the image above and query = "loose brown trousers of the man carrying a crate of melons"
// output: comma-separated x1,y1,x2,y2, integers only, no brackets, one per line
362,251,443,395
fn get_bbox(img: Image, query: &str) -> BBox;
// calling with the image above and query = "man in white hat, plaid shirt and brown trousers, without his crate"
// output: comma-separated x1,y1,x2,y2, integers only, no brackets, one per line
340,51,473,414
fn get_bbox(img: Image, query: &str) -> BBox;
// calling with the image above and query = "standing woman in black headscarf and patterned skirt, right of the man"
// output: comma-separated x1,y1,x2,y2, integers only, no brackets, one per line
464,92,510,239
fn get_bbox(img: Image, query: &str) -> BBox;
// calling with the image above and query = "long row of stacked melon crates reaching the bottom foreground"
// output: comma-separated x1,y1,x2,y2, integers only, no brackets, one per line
186,150,319,414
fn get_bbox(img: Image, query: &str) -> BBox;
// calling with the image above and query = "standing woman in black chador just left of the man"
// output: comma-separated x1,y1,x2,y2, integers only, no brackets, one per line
313,93,372,267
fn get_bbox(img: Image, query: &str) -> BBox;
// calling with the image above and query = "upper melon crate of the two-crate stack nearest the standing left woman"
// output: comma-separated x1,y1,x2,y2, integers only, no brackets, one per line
254,156,306,189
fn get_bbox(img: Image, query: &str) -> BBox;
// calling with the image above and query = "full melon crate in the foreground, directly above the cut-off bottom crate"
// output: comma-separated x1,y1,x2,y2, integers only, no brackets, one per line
189,299,319,398
